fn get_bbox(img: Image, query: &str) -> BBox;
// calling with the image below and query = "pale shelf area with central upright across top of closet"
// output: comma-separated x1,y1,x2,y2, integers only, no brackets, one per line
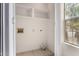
16,3,50,19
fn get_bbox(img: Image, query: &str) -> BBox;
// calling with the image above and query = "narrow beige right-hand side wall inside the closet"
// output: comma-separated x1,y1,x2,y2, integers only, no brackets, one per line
47,4,55,52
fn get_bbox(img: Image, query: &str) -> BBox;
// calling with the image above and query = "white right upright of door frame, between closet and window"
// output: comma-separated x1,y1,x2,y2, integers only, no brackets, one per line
54,3,64,56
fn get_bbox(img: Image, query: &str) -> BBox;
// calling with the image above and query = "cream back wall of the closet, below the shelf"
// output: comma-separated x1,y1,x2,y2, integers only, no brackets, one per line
16,16,48,52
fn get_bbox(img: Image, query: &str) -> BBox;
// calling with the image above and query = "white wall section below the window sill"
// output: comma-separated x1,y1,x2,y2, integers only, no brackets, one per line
63,44,79,56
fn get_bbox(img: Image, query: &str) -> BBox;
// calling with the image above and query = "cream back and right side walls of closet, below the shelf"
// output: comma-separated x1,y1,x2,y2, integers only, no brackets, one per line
16,5,54,52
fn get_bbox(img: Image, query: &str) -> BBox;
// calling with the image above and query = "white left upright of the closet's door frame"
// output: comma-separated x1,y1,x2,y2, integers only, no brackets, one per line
9,3,16,56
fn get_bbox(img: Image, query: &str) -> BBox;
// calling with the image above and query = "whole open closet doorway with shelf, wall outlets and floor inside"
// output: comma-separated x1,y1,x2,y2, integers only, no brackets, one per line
15,3,55,56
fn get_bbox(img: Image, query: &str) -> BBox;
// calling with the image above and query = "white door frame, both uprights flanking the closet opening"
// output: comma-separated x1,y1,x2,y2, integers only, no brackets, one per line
9,3,64,56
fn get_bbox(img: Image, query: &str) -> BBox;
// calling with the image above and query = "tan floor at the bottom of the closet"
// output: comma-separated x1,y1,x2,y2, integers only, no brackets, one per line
16,49,54,56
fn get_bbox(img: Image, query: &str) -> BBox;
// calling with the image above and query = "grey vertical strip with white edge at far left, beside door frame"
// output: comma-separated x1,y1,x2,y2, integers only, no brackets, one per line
2,3,9,56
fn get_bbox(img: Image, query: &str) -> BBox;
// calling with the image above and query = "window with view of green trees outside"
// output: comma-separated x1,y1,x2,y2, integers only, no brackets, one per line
64,3,79,46
